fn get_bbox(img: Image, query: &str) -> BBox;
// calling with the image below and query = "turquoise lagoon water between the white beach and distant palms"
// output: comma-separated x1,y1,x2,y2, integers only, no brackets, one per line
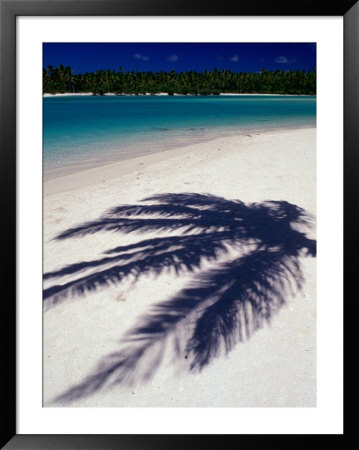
43,95,316,176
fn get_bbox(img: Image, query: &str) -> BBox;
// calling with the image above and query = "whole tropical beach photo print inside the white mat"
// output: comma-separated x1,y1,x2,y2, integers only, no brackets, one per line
43,42,317,408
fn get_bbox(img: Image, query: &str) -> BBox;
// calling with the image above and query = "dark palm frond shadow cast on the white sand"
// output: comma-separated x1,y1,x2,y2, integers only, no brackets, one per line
44,193,316,403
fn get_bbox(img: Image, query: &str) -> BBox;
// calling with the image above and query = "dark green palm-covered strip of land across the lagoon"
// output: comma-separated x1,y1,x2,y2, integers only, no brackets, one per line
43,64,316,95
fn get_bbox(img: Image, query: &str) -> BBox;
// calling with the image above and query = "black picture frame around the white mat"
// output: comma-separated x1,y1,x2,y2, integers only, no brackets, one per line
0,0,359,450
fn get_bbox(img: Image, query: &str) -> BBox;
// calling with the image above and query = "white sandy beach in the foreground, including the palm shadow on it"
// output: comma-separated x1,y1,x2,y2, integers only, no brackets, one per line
43,128,316,407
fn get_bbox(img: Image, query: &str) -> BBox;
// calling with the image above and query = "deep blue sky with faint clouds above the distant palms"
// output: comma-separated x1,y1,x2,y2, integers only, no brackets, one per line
43,43,316,73
